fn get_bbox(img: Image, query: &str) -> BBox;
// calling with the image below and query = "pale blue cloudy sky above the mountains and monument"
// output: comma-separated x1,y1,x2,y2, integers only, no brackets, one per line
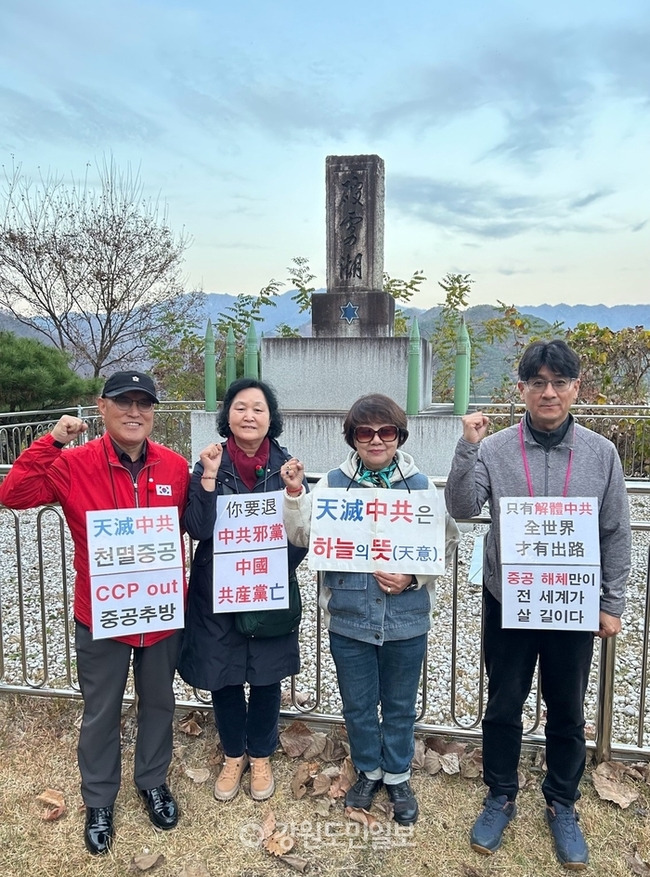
0,0,650,307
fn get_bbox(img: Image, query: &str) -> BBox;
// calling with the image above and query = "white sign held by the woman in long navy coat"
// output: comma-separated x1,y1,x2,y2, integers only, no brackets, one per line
213,490,289,612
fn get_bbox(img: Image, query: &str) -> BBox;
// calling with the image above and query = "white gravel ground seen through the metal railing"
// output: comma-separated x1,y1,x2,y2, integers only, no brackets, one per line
0,497,650,747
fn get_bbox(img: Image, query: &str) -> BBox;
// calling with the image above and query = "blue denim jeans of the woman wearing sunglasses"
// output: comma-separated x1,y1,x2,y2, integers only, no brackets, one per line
330,632,427,783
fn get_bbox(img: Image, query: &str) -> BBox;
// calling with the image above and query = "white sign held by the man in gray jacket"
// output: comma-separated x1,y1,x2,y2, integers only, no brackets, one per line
499,496,600,631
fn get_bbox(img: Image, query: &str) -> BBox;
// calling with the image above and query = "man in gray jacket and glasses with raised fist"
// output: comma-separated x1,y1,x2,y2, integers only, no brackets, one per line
445,340,631,870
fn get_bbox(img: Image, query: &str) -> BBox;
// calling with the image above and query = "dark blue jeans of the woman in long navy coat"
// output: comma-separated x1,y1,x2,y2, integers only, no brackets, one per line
212,682,281,758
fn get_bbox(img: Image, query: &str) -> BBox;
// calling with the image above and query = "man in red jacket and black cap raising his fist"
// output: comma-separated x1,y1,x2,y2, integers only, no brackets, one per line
0,371,189,855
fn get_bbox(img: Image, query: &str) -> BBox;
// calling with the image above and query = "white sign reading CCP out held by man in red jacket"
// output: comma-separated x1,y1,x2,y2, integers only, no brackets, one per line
86,506,184,639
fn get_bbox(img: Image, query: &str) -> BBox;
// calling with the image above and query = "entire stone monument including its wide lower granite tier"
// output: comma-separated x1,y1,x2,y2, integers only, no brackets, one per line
192,155,461,477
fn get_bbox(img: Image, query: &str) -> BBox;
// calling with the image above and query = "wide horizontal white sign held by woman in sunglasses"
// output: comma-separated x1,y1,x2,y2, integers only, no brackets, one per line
309,487,445,575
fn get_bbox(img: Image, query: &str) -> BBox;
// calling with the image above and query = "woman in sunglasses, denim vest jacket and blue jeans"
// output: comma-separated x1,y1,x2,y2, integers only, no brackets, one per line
281,393,458,825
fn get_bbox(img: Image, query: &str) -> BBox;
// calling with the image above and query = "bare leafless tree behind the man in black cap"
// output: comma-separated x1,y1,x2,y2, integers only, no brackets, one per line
0,159,190,377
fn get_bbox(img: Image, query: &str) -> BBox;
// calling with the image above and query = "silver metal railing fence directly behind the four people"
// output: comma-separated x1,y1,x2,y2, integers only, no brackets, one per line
0,476,650,759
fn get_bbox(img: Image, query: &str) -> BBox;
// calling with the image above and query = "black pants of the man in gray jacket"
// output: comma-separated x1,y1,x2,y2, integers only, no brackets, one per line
483,589,594,806
